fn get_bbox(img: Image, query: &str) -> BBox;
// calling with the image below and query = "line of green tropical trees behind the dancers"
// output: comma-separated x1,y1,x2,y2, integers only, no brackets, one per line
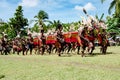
0,0,120,38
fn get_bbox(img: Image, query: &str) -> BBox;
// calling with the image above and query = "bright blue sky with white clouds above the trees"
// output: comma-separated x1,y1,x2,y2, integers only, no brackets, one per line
0,0,112,23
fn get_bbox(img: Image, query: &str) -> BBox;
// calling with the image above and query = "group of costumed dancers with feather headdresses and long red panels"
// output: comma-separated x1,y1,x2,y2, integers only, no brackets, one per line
0,20,109,57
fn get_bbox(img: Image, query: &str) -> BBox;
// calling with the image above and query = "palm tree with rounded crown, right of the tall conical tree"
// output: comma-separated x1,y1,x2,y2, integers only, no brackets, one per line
34,10,49,28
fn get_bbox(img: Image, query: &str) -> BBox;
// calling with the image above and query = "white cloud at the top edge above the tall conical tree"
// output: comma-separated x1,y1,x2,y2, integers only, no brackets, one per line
19,0,39,7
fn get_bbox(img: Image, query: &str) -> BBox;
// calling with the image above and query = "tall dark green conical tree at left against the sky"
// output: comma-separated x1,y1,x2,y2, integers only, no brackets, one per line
9,6,28,37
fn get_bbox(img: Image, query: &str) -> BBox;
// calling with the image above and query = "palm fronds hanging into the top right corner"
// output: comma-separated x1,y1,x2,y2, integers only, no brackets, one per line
101,0,120,17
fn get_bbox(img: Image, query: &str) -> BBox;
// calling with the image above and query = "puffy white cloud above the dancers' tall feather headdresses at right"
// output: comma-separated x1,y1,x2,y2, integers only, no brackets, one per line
74,2,96,11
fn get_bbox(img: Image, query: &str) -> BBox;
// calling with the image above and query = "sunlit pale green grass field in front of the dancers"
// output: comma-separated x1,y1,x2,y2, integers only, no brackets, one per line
0,47,120,80
